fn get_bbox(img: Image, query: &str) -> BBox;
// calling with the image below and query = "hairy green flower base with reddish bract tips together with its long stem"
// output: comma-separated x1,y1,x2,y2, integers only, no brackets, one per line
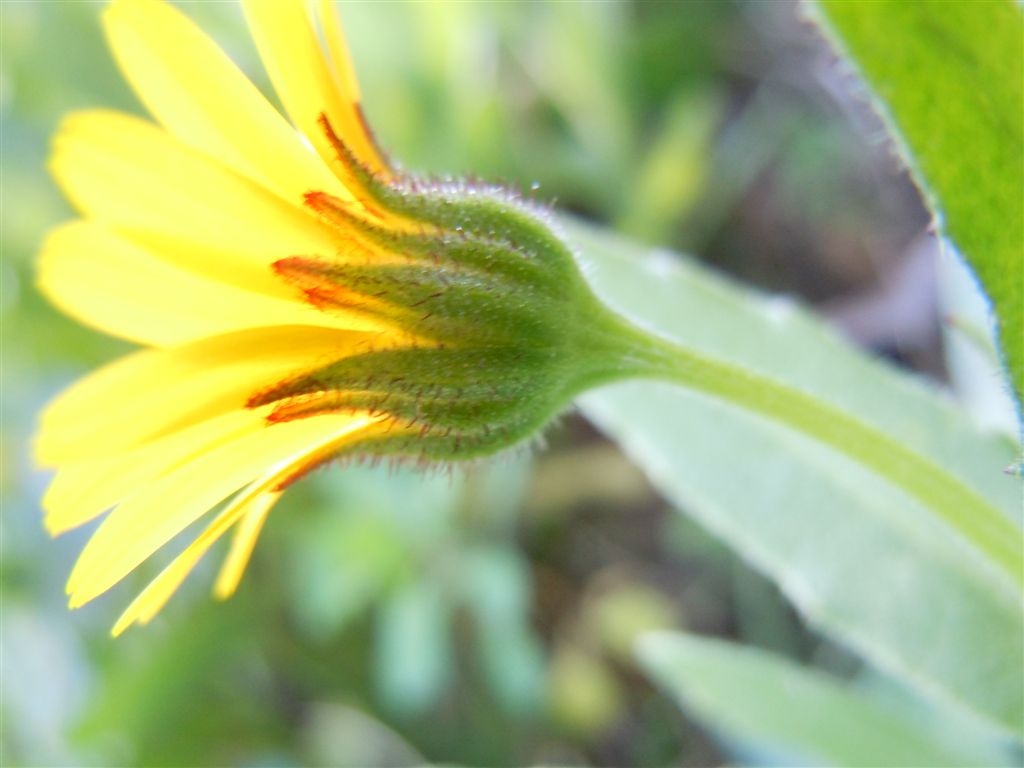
250,121,1024,589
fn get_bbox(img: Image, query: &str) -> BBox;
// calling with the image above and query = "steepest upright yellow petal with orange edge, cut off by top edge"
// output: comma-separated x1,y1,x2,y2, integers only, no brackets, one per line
243,0,384,179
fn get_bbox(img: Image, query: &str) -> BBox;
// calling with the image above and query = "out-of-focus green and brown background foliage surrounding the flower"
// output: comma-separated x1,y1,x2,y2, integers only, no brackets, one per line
0,0,1005,766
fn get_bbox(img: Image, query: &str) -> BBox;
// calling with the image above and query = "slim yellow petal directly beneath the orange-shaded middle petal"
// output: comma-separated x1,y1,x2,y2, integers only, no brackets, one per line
42,408,270,536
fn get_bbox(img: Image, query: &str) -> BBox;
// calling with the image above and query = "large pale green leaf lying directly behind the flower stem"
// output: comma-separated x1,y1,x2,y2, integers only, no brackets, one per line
572,219,1024,733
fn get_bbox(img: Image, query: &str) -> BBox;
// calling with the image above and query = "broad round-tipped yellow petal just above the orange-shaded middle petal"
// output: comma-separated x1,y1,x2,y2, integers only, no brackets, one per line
38,221,376,346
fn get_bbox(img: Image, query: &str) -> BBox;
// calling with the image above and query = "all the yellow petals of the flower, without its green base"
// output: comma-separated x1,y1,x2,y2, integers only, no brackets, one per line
37,0,408,634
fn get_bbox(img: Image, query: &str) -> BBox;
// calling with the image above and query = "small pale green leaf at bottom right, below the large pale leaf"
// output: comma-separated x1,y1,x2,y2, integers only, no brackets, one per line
637,633,998,768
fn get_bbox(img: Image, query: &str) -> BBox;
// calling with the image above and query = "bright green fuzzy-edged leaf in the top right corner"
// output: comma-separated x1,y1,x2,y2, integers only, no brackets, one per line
815,0,1024,415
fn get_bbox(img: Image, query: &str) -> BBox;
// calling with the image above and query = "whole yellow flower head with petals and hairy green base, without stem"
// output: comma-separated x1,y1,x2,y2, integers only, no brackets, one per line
37,0,655,634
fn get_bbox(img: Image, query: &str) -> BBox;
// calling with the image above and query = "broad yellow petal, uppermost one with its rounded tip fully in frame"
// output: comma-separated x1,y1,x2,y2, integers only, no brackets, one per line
50,112,338,298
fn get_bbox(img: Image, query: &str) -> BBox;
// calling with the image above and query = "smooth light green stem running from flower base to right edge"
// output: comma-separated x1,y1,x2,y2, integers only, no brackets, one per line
577,303,1024,591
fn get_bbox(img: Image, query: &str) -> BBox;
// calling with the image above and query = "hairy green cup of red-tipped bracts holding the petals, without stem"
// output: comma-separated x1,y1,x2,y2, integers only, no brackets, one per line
264,126,635,463
